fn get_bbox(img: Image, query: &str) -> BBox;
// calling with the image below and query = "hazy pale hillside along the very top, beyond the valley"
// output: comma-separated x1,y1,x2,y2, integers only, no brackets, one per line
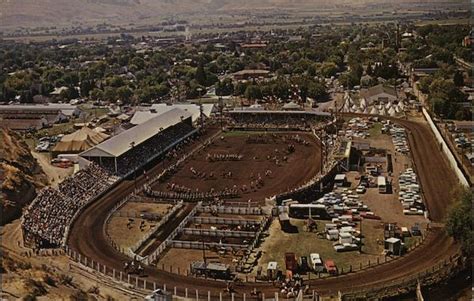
0,0,460,27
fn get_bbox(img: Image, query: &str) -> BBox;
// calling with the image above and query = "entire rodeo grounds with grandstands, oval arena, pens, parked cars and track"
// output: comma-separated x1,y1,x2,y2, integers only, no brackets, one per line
21,98,470,300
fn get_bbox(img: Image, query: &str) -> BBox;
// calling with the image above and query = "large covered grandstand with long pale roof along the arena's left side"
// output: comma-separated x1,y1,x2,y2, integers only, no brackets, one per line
80,108,197,177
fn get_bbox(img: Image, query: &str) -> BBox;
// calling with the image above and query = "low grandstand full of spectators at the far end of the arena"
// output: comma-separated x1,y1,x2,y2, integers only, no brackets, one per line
226,110,331,131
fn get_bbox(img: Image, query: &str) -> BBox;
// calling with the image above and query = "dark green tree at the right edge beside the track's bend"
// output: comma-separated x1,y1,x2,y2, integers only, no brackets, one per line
445,188,474,257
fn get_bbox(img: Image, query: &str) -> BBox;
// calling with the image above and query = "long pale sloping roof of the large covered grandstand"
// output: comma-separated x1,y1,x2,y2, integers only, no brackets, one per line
81,108,191,157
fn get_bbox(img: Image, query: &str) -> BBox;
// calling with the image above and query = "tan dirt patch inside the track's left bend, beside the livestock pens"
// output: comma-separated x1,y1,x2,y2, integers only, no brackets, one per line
107,202,172,248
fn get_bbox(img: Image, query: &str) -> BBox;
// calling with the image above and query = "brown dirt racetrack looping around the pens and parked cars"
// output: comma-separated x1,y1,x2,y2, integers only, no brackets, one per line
68,119,458,296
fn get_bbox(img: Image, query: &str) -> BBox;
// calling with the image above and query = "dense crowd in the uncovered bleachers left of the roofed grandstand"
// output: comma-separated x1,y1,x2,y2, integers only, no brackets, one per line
22,163,112,248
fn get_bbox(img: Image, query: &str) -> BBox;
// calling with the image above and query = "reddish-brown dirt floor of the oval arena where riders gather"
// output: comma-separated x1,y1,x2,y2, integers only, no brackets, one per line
153,132,320,201
